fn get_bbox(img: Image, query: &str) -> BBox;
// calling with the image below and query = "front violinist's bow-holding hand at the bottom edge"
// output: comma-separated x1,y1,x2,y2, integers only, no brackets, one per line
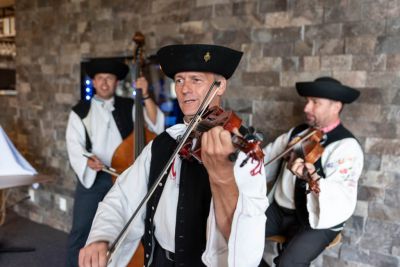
79,241,108,267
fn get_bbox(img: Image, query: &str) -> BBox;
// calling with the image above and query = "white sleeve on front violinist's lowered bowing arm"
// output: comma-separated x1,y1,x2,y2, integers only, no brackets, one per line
86,142,152,266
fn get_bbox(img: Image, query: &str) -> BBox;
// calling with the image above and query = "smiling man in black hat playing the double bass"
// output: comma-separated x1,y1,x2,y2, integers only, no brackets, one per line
66,58,164,266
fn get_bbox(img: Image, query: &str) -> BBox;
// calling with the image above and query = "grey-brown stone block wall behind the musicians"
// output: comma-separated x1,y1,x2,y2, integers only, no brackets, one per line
0,0,400,266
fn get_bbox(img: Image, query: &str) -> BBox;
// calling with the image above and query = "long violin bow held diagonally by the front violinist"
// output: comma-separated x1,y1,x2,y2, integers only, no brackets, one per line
107,80,221,265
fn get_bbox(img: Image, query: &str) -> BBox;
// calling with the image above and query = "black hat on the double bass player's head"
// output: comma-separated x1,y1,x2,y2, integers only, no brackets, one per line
86,58,129,80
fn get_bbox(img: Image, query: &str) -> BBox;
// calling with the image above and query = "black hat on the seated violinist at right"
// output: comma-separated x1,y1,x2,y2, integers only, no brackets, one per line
296,77,360,104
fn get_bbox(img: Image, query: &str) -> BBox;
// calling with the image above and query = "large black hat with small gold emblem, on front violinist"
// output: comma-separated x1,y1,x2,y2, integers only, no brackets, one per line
157,44,243,79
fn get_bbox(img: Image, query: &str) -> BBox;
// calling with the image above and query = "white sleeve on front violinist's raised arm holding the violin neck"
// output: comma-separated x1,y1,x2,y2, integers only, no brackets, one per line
202,153,268,267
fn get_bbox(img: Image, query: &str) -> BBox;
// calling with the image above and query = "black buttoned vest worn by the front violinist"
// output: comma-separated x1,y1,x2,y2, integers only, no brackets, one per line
143,132,211,267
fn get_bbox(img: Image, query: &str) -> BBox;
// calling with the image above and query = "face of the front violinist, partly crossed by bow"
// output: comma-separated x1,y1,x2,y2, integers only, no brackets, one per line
175,71,226,119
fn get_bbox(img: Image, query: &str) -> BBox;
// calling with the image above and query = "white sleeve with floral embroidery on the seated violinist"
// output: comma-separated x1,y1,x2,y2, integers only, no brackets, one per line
307,138,364,229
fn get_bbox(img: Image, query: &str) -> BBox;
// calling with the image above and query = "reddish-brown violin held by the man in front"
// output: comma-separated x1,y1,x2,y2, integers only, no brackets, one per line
179,106,264,166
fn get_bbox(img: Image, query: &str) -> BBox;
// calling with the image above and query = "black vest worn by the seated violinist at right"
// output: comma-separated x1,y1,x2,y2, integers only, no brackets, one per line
290,124,356,228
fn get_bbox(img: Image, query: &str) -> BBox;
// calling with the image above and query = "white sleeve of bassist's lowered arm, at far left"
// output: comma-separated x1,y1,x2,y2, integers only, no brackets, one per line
65,111,97,188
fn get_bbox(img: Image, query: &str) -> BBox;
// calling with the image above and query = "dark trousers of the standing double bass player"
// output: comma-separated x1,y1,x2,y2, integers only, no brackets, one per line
66,172,113,267
